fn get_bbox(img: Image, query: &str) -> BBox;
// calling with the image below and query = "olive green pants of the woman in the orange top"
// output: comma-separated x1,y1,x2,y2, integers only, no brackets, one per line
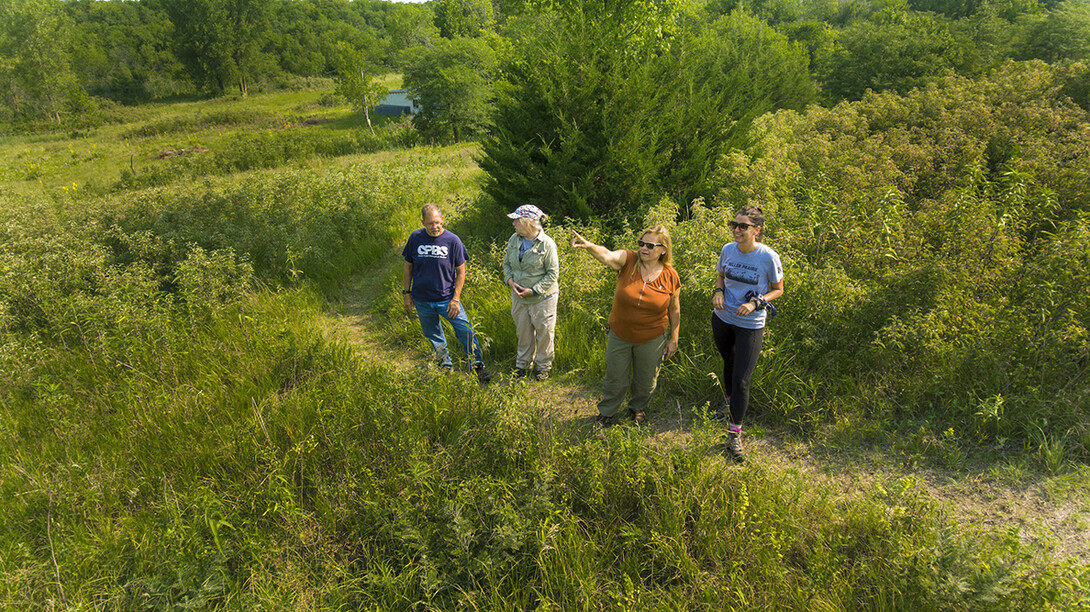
598,329,668,417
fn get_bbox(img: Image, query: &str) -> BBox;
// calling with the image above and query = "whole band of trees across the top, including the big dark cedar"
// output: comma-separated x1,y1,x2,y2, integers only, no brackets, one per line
0,0,1090,217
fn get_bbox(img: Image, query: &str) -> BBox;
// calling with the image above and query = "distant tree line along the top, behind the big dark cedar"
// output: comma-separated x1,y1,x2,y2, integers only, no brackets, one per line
0,0,1090,110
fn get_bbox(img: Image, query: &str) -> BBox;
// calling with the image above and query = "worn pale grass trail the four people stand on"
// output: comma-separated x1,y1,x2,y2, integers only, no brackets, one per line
324,243,1090,560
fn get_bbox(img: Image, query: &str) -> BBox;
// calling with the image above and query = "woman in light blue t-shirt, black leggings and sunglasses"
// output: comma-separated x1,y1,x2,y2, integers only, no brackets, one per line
712,206,784,461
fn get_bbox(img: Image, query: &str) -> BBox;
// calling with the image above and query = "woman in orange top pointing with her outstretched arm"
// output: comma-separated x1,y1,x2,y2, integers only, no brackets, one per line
571,225,681,425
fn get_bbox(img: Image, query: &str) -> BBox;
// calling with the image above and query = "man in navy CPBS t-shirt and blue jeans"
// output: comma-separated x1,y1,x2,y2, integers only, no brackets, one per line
401,204,492,383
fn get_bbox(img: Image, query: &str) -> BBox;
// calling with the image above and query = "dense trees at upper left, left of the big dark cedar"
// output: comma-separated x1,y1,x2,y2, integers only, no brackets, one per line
0,0,439,114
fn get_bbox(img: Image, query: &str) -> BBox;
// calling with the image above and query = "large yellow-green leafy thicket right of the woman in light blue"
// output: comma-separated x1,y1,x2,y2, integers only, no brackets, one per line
706,63,1090,454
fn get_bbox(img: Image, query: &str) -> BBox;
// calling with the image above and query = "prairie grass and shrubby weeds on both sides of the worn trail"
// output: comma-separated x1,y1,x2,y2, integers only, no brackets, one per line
0,64,1090,610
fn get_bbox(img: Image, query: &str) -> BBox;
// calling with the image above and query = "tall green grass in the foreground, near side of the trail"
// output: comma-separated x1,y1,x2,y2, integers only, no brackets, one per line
0,291,1086,610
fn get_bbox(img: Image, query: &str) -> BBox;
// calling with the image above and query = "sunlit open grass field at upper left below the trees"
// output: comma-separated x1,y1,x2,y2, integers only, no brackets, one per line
0,84,407,197
